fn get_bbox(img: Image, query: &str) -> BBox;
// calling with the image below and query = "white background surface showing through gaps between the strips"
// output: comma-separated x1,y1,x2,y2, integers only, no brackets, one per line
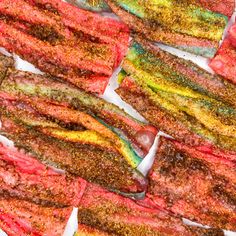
0,7,236,236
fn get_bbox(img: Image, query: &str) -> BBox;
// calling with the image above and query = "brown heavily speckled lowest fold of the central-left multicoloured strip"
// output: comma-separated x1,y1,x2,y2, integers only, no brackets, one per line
1,109,146,193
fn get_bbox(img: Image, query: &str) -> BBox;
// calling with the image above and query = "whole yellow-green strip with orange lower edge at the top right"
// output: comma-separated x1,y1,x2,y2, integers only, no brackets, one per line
107,0,228,58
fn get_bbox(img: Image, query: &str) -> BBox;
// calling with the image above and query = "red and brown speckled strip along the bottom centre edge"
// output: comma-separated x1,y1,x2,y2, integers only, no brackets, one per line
78,184,223,236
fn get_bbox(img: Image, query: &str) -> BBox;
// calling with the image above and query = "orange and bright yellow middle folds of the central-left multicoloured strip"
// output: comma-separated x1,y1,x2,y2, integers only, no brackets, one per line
0,97,144,168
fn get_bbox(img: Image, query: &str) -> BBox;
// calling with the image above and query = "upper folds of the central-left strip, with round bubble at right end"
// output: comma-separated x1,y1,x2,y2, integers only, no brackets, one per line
0,57,157,159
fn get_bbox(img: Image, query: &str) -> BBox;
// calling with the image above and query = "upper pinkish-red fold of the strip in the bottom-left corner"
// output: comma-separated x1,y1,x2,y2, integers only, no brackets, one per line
0,144,86,207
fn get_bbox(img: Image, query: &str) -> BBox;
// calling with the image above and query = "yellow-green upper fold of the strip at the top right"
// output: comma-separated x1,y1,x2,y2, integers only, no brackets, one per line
115,0,228,41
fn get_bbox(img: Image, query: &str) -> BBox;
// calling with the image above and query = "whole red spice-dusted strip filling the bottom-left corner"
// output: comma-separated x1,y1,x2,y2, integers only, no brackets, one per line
0,144,81,236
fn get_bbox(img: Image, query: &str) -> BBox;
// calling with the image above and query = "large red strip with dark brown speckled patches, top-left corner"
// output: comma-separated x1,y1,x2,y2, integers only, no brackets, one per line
0,0,129,93
